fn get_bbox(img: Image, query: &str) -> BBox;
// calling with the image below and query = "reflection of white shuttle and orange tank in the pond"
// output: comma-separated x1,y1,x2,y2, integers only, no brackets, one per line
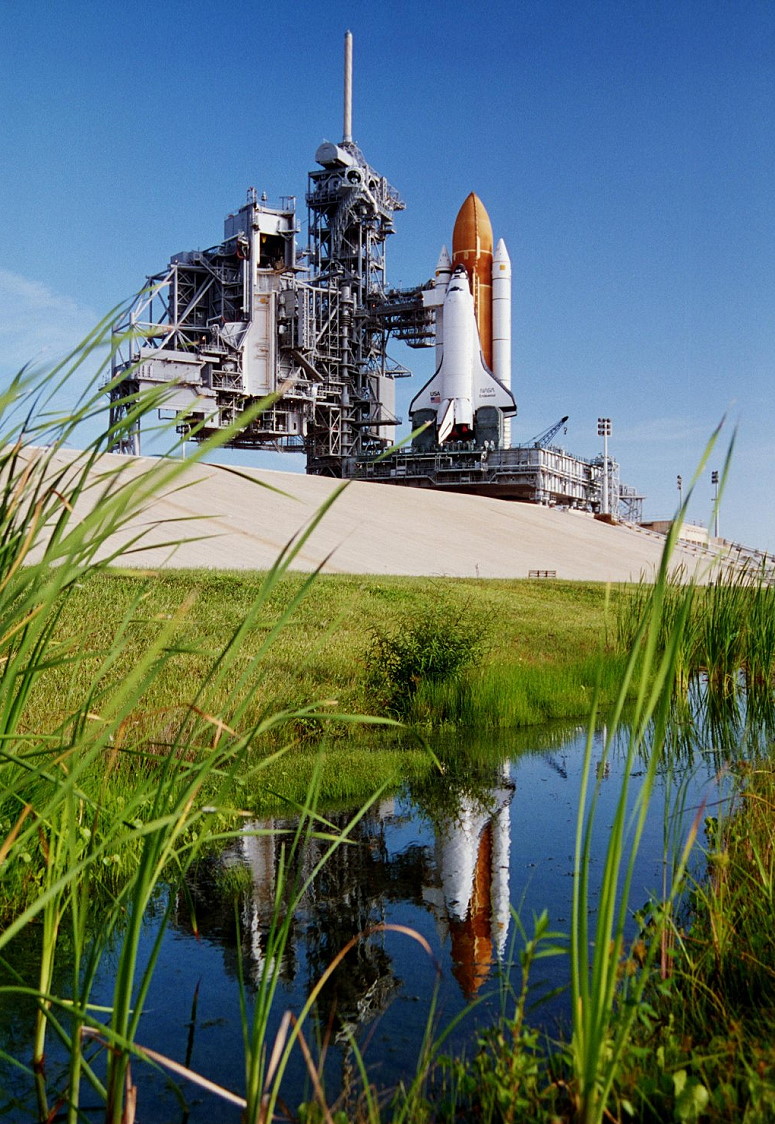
425,763,514,998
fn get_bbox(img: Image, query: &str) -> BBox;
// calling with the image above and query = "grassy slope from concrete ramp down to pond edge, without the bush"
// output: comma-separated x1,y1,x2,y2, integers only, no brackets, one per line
27,571,613,804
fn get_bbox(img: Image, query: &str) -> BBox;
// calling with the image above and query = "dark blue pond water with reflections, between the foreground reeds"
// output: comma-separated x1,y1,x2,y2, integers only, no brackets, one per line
0,726,741,1124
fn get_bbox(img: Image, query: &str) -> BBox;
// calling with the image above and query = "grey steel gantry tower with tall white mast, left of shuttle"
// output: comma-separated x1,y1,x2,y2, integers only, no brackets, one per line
110,33,409,477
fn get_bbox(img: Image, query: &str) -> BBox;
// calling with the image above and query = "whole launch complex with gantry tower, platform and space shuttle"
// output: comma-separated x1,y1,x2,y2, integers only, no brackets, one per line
110,33,642,522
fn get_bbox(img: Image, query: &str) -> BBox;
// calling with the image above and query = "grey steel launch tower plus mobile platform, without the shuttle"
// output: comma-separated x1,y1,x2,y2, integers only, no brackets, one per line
103,37,642,520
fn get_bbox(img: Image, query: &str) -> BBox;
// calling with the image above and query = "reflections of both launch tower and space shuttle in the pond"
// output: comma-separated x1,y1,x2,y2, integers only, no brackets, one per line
235,763,514,1011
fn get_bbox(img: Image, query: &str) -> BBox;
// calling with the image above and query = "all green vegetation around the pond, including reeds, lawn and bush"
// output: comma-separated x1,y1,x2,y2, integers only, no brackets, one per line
0,334,775,1124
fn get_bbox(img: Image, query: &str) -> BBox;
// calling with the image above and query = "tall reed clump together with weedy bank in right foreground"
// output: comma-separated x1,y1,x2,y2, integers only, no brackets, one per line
404,422,759,1124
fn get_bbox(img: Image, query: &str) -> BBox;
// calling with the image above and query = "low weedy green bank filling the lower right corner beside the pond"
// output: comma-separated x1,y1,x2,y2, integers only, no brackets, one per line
424,737,775,1124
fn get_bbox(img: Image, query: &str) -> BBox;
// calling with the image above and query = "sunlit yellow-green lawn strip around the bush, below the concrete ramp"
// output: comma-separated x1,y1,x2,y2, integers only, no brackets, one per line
24,570,621,759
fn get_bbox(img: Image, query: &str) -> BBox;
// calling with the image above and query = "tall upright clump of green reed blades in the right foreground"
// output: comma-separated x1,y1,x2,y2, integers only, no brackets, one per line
568,514,696,1124
